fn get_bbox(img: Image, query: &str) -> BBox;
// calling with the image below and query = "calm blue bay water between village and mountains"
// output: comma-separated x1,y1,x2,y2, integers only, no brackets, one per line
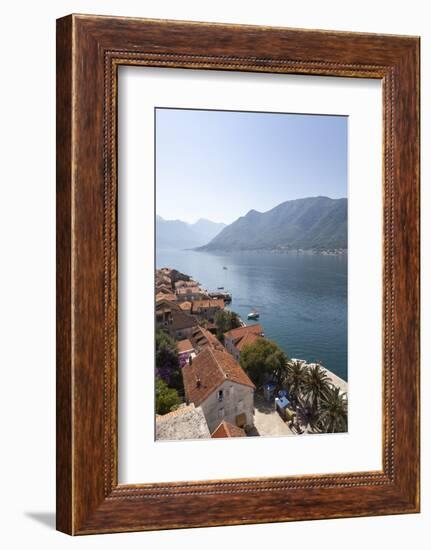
156,249,347,380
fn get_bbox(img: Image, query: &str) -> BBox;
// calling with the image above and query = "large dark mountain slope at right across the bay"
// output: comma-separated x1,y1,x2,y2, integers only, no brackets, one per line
198,197,347,251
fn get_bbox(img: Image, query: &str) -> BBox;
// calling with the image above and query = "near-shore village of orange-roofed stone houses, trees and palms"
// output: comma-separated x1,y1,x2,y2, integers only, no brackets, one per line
155,268,348,440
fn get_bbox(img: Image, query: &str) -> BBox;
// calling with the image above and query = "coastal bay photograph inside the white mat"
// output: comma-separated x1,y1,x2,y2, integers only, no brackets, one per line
154,107,348,441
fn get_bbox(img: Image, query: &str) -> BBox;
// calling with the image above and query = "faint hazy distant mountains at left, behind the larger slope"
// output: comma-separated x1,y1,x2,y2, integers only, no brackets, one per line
156,216,226,249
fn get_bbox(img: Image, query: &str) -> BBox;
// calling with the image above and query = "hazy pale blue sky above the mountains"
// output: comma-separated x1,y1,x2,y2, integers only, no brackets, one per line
156,109,347,223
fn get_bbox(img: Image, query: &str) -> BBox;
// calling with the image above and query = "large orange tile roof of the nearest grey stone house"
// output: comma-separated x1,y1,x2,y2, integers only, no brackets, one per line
181,346,255,406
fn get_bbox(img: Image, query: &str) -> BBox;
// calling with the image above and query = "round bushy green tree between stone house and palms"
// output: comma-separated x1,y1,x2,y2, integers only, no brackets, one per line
240,338,288,386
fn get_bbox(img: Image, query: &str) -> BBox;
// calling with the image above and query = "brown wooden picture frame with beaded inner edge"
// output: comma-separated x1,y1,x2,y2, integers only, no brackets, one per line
57,15,419,535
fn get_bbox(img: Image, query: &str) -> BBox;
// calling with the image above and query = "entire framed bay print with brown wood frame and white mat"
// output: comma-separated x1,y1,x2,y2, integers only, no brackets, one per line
57,15,419,534
